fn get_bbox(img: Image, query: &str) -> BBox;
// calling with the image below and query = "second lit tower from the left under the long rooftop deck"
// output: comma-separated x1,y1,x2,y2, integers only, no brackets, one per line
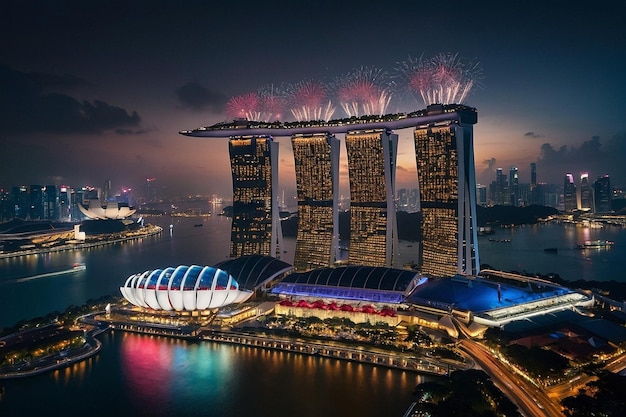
291,133,339,272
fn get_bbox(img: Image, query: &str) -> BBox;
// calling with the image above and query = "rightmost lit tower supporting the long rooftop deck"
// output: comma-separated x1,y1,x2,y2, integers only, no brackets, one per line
414,106,478,276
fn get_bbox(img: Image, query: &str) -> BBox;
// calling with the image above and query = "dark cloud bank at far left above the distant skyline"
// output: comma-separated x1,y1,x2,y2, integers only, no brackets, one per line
0,65,141,133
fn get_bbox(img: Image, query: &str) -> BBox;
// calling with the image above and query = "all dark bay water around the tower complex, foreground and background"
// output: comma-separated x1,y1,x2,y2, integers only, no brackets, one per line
0,203,626,417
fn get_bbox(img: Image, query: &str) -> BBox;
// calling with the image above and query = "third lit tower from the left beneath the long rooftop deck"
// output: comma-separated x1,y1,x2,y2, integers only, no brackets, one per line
346,129,398,267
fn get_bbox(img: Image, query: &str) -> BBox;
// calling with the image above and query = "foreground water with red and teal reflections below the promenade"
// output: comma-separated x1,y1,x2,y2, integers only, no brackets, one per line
0,331,432,417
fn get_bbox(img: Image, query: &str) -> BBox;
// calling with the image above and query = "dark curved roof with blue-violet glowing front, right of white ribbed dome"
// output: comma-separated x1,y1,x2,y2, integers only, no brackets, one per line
272,266,419,304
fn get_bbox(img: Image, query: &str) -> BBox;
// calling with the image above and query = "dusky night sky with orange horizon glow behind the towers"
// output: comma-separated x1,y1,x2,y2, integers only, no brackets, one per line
0,0,626,202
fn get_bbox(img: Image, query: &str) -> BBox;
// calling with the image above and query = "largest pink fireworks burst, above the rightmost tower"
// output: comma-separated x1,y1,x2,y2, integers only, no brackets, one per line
398,53,481,106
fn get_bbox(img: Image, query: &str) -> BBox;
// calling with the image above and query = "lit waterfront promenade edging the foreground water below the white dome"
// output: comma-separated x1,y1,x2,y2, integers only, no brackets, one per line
0,304,468,379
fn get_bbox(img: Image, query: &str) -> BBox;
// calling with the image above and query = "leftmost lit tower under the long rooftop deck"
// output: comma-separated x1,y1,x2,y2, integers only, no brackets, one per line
228,136,282,258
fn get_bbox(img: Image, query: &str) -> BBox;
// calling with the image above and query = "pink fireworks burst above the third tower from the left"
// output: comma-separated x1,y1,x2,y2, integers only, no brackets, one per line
335,67,392,117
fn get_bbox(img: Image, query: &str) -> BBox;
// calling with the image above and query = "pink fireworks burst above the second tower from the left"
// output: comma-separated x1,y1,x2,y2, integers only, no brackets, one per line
287,81,335,122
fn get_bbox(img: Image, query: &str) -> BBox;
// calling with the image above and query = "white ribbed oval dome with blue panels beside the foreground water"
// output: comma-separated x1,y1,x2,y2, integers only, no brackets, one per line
120,265,253,311
